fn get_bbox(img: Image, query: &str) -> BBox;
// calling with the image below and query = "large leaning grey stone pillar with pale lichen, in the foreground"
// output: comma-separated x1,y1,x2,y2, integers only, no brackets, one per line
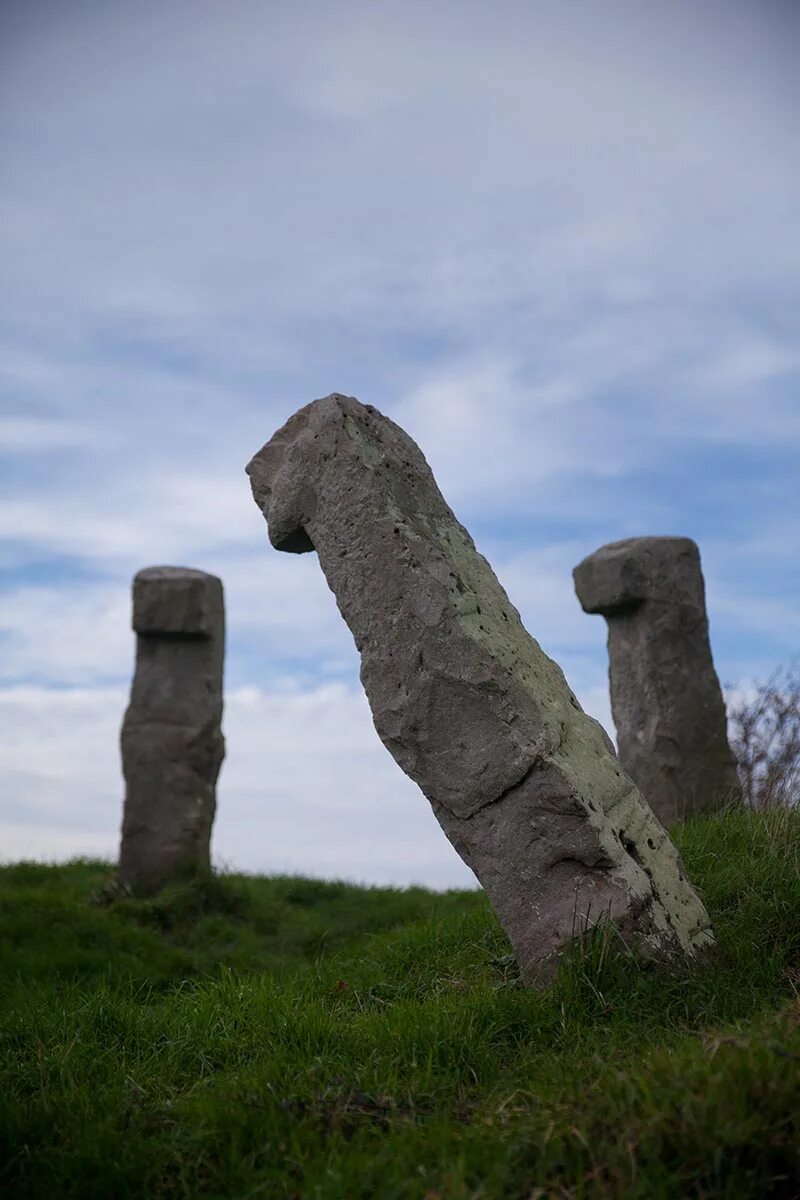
247,395,711,982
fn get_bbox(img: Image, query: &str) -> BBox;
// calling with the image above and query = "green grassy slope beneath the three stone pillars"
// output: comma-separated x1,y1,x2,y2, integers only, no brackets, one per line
0,812,800,1200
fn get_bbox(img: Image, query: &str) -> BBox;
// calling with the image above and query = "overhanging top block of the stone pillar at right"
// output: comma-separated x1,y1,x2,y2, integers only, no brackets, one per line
572,538,700,617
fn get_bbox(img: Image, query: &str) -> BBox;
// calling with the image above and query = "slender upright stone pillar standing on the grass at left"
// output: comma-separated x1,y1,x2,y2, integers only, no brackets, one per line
119,566,224,895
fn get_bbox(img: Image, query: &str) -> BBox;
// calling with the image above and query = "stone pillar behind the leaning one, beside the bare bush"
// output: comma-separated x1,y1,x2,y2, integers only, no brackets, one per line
573,538,741,824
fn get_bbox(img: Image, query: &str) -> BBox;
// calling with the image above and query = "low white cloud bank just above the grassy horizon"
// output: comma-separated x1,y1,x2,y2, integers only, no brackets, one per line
0,684,607,887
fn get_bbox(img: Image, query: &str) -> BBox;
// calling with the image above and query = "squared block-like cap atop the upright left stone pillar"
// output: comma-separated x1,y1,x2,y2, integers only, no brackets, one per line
133,566,224,637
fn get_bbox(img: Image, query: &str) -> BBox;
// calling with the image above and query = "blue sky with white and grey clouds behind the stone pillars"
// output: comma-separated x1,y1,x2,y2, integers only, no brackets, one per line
0,0,800,886
